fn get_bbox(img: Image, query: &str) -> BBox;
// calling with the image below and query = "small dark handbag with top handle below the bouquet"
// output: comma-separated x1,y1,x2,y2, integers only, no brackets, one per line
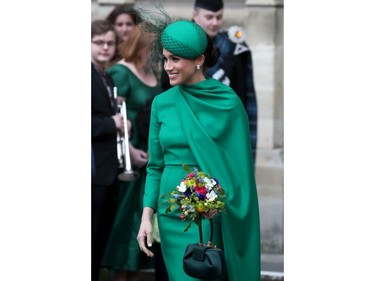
183,219,227,280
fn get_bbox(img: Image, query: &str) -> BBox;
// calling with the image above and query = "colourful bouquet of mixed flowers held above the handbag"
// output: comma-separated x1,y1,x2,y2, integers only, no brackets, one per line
165,164,225,232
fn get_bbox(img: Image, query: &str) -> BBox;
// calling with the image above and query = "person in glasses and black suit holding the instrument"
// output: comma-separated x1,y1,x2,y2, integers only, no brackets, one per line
91,20,124,280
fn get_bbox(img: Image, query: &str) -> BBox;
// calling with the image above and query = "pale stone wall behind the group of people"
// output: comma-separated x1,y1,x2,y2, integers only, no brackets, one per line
91,0,284,254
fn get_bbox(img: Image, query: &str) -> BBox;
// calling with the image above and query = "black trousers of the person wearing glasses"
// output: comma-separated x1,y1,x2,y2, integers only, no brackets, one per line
91,179,118,280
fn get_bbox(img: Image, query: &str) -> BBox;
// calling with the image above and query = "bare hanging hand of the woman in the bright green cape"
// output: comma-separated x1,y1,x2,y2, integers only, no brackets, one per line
137,207,154,257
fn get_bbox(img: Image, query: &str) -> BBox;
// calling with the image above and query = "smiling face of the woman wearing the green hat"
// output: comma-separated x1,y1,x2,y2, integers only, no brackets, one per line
163,49,202,86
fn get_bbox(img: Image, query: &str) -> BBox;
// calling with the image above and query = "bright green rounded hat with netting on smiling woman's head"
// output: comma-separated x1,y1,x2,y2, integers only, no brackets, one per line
160,20,207,59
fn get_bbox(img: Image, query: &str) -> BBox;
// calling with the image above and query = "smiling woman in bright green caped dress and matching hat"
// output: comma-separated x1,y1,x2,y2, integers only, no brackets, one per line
137,20,260,281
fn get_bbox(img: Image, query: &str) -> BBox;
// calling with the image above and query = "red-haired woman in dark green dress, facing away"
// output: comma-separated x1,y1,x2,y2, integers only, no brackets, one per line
102,26,162,281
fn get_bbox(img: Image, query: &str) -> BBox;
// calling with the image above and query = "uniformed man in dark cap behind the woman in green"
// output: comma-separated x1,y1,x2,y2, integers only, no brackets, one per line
193,0,257,166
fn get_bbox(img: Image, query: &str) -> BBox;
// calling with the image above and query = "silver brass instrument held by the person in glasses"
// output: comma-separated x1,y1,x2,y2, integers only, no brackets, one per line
114,87,139,181
